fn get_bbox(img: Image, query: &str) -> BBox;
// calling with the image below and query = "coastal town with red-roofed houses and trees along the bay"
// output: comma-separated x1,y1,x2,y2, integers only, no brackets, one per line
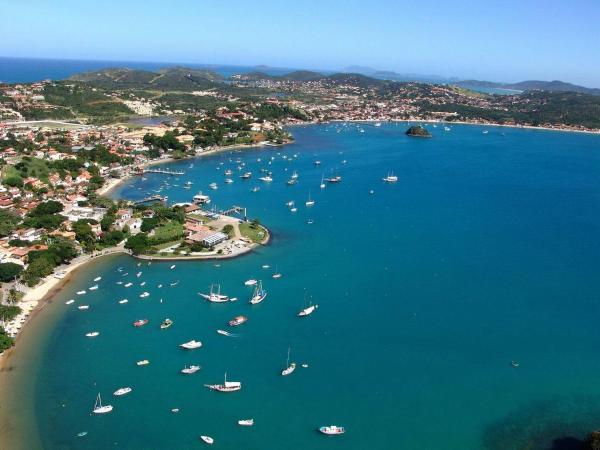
0,68,598,351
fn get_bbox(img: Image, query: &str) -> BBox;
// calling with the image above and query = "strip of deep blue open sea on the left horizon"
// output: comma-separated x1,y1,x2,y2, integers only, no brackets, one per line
0,57,294,83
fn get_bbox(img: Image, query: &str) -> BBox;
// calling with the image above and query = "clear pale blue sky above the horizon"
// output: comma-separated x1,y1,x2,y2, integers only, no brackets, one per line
0,0,600,87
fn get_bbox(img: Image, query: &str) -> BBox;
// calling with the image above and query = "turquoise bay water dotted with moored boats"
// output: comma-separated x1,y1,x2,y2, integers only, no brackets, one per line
34,124,600,450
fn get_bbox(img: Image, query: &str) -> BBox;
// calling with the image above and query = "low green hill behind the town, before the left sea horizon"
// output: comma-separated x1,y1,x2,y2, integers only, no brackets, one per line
69,67,223,90
